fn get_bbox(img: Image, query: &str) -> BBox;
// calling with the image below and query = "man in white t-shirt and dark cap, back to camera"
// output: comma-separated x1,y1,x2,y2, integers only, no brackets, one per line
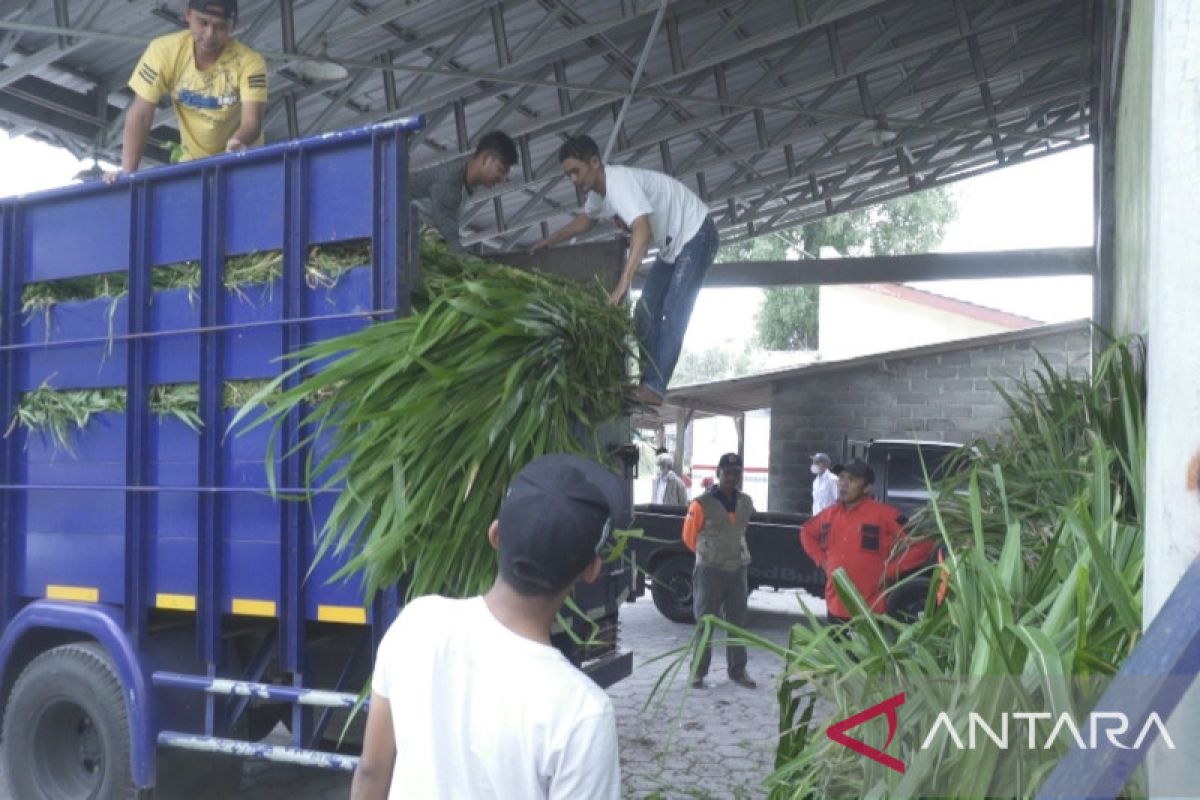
350,455,630,800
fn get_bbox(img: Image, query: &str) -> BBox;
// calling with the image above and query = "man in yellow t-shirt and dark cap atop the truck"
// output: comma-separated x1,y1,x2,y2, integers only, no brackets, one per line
106,0,266,182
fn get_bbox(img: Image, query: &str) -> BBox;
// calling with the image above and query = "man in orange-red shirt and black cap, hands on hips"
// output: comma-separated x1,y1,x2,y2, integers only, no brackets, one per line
800,458,934,622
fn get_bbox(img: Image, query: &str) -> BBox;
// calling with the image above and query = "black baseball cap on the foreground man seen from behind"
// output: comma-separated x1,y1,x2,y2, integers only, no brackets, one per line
499,453,632,595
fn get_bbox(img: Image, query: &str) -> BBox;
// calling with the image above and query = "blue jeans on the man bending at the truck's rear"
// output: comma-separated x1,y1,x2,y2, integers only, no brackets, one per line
634,217,721,395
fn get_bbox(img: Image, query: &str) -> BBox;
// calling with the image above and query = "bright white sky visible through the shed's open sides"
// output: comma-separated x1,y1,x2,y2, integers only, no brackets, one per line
0,132,1092,350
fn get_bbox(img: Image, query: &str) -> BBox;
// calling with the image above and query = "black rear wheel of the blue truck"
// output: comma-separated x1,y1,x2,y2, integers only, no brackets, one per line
4,642,137,800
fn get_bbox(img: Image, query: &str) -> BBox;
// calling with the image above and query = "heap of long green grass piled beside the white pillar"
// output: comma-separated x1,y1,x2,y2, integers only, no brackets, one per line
770,341,1146,798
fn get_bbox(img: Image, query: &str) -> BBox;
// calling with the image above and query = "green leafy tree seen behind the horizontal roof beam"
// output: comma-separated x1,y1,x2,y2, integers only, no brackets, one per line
719,187,958,350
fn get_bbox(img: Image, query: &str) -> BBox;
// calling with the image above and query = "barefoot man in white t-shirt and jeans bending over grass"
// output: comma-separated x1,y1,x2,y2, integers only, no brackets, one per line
533,136,720,405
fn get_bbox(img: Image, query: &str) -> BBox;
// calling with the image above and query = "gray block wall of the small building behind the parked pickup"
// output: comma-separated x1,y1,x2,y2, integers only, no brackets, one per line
769,325,1091,512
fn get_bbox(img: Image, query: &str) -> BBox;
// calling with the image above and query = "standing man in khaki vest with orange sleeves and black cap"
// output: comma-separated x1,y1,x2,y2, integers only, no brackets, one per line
683,453,757,688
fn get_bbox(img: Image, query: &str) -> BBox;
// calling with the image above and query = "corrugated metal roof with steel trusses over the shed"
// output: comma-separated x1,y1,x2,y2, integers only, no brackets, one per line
0,0,1098,248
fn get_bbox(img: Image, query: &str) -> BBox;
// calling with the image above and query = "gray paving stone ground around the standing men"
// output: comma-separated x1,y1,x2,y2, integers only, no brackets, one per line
0,590,824,800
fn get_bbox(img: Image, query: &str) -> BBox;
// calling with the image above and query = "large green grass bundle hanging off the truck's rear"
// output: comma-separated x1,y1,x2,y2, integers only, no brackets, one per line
235,241,632,604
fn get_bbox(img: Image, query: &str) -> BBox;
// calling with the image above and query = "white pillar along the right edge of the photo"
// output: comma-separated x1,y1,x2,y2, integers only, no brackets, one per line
1144,0,1200,796
